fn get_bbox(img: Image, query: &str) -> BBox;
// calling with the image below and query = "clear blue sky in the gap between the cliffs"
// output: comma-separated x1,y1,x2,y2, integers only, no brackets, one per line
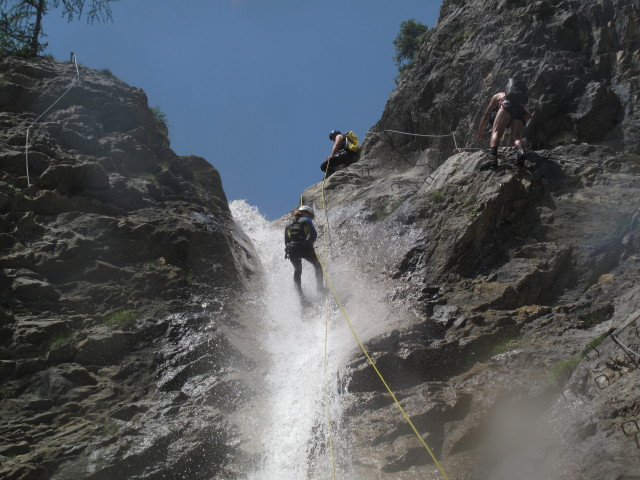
44,0,441,219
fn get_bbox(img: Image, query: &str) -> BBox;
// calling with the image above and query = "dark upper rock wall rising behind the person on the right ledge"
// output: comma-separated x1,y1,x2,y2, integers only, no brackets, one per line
365,0,640,166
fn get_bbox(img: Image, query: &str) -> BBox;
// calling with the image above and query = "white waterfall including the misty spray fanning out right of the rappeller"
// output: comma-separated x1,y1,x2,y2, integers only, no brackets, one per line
230,200,416,480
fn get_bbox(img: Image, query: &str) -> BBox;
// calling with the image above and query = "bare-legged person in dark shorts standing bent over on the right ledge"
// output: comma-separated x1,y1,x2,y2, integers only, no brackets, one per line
476,78,532,169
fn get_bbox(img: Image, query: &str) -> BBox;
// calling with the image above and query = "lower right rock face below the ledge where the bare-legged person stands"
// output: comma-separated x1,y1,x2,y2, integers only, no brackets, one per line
303,149,640,480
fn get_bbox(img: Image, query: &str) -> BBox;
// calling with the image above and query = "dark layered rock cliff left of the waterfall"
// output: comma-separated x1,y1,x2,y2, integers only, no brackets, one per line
0,57,257,480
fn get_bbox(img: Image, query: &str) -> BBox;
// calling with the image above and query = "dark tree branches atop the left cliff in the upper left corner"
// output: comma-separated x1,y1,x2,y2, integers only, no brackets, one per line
0,0,116,57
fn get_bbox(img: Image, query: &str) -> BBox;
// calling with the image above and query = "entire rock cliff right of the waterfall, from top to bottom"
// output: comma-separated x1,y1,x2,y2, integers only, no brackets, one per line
303,0,640,480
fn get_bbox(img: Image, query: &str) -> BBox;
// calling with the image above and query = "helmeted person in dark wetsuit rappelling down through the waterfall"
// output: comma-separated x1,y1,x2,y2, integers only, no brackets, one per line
284,205,324,294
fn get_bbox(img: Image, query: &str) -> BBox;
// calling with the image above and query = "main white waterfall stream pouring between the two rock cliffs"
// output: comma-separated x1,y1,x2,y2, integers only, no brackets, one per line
230,201,355,480
